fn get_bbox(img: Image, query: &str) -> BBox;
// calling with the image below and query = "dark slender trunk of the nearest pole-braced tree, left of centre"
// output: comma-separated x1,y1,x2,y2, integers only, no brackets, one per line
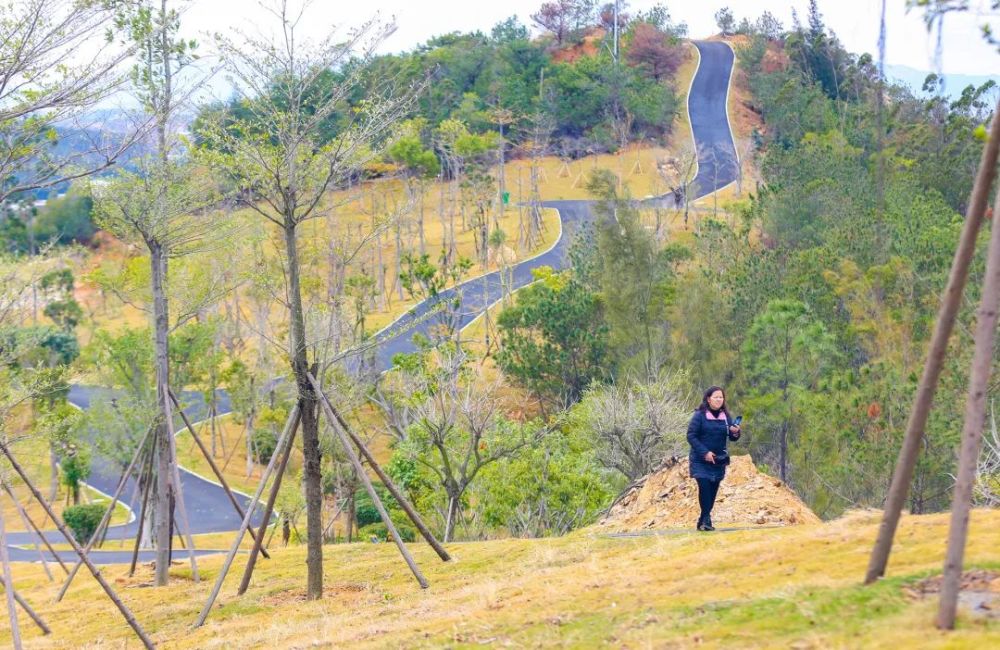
284,217,323,600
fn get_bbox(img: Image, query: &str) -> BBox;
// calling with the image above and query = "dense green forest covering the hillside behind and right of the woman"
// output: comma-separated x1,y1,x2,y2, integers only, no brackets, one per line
674,3,995,516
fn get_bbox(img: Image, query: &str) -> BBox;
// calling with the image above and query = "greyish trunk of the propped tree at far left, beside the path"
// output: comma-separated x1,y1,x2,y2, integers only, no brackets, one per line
149,241,172,586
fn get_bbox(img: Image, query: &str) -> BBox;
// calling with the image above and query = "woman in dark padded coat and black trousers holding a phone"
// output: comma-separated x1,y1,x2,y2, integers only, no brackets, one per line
688,386,740,531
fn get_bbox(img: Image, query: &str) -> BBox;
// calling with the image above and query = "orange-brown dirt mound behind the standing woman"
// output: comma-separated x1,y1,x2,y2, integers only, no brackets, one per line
598,456,819,531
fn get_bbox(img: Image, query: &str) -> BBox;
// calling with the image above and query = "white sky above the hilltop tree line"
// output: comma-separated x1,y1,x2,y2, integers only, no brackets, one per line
183,0,1000,75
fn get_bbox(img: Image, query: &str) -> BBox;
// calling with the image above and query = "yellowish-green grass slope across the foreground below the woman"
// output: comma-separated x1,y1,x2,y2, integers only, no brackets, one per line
0,511,1000,648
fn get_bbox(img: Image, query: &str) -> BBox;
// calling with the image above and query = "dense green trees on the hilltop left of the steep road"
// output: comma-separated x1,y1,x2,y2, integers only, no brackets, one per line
193,8,687,177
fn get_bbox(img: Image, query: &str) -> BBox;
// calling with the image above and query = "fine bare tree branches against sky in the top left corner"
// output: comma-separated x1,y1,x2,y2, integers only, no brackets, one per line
0,0,146,203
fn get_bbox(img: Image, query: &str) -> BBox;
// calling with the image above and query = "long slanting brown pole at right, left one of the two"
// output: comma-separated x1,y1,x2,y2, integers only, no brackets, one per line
865,102,1000,584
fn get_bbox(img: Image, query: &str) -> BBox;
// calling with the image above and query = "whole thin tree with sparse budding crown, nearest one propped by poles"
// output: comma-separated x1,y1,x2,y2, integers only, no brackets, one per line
203,1,414,599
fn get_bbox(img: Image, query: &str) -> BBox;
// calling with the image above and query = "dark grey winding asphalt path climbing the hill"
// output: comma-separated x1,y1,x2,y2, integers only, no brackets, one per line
8,41,739,564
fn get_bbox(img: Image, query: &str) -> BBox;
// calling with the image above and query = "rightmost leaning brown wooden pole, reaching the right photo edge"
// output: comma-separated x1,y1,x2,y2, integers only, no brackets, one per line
937,185,1000,630
